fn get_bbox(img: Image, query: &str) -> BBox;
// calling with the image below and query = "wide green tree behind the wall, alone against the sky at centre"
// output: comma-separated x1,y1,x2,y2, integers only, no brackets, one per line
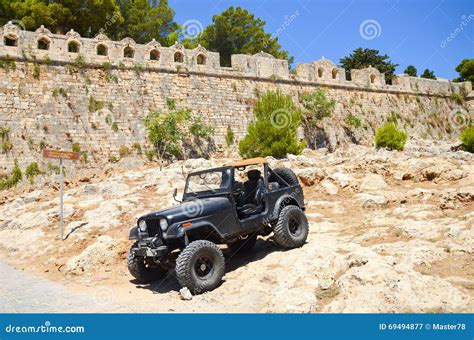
194,7,293,66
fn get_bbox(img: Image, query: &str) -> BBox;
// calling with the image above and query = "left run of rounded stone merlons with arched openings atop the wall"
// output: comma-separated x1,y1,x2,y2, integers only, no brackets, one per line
0,23,219,71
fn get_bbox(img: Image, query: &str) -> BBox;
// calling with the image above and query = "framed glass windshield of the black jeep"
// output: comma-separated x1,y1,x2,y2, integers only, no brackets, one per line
184,168,231,196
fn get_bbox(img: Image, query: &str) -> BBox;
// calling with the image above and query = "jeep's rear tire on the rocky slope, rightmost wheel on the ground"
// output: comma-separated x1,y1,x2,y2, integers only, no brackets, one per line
273,205,309,248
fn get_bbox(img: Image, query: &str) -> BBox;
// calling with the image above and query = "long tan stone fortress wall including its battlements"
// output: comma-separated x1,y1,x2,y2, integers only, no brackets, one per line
0,23,473,168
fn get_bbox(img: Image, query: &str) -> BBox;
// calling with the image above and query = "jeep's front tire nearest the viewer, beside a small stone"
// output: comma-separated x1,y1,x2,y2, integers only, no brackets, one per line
176,240,225,294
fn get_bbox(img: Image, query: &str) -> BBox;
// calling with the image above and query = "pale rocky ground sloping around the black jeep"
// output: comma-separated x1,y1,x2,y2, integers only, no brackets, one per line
0,141,474,313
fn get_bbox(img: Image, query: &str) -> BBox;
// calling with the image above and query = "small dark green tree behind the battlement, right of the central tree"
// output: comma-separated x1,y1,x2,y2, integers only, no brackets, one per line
339,47,398,84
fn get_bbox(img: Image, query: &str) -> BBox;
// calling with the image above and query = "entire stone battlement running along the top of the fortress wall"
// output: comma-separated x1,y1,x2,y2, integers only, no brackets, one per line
0,22,472,95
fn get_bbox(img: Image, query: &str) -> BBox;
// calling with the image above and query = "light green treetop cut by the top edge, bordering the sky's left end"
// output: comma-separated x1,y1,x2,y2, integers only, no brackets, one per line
115,0,179,46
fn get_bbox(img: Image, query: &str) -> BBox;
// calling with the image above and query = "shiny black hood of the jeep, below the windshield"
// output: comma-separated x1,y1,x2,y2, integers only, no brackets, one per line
140,197,231,224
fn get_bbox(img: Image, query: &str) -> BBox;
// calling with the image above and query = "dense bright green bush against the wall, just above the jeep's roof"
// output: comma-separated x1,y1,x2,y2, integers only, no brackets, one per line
239,91,305,158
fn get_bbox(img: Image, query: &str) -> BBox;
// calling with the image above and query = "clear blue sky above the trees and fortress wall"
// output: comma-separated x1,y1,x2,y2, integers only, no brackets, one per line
169,0,474,79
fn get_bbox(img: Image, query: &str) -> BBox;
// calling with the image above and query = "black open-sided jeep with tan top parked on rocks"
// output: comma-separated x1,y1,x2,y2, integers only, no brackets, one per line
128,158,308,294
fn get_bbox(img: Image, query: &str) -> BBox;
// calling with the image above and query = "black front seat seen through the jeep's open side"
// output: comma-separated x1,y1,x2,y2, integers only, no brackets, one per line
237,170,264,216
